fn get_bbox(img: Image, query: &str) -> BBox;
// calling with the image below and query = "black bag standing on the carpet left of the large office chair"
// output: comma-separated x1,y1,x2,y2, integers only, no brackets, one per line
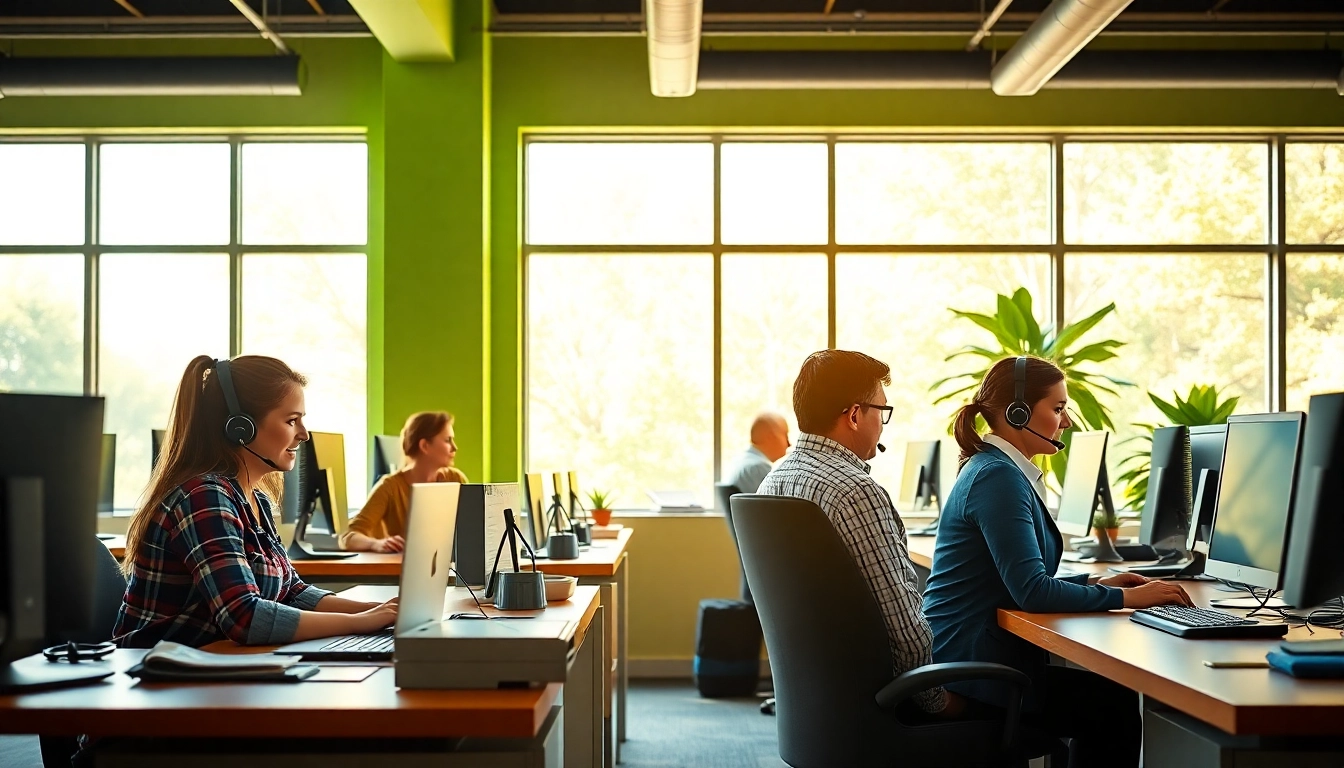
695,600,761,698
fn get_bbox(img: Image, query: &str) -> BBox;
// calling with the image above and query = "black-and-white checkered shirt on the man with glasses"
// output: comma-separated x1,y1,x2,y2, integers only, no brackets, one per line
757,432,948,712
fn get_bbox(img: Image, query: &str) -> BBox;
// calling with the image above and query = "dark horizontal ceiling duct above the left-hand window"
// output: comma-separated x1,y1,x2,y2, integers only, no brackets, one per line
0,56,304,97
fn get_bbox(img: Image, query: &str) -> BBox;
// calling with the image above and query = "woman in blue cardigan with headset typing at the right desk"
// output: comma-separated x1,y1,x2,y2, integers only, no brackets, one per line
923,356,1191,768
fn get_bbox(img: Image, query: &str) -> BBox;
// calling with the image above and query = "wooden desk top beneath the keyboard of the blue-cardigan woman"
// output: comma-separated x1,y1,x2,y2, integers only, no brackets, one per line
910,537,1344,736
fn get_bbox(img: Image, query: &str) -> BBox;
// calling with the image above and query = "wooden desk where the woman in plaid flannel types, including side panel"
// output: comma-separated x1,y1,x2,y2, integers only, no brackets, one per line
0,586,605,768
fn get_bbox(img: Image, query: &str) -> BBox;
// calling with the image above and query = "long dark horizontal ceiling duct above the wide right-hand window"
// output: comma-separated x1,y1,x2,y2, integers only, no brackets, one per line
699,50,1344,91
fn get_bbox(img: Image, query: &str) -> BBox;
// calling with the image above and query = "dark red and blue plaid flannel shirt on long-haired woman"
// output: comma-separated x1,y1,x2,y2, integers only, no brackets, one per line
113,475,331,648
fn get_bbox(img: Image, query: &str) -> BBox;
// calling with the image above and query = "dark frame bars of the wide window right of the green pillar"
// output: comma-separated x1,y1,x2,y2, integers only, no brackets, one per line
517,130,1344,492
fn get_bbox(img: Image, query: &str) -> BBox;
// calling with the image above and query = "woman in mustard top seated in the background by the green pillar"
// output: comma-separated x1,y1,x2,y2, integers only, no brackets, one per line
340,410,466,551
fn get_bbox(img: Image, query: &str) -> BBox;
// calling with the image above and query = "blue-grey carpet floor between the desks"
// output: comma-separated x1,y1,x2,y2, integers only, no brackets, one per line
0,681,784,768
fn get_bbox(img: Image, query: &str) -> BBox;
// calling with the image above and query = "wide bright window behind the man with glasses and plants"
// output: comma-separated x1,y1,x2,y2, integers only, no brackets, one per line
523,136,1344,507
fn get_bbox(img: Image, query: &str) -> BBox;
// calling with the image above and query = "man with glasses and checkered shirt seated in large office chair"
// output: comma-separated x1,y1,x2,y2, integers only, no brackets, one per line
757,350,962,717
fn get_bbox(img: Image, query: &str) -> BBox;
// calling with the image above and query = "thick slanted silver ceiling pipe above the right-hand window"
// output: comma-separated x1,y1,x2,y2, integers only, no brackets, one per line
989,0,1132,95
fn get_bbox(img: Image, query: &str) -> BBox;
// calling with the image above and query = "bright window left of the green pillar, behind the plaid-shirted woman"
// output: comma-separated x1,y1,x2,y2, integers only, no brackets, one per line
0,137,368,514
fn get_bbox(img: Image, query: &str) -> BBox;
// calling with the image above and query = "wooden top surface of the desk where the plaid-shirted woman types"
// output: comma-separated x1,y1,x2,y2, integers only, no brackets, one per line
0,586,598,738
